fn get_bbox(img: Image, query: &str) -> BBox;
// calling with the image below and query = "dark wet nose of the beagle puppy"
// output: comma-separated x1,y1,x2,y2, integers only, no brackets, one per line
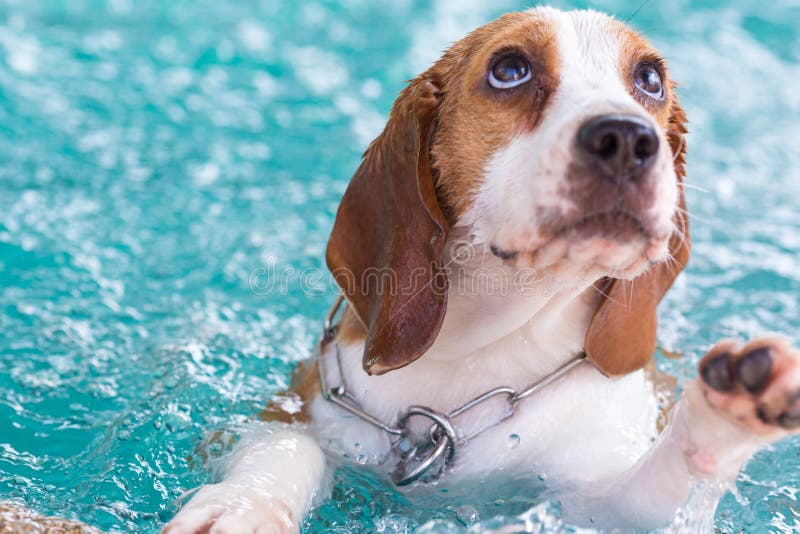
578,115,658,181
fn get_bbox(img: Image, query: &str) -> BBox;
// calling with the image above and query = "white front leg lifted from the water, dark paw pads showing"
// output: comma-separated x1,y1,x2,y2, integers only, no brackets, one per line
568,338,800,528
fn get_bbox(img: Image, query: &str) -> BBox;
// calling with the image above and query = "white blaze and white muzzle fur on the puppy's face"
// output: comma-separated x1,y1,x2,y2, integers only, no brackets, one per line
459,8,678,274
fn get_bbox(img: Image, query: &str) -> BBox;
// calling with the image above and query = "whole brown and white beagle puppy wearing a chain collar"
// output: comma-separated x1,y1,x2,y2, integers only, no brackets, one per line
165,8,800,533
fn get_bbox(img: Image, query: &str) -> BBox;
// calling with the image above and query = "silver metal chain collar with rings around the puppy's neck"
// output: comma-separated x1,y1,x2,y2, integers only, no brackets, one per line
318,295,586,486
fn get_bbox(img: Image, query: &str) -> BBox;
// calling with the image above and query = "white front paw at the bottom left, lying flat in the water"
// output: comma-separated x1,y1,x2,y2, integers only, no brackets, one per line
163,483,299,534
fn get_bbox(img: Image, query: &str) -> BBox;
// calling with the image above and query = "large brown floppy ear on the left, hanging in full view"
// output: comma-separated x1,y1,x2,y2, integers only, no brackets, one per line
326,74,449,374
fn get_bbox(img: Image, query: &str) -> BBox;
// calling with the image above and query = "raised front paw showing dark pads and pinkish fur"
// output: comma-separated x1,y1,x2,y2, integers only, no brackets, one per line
700,337,800,439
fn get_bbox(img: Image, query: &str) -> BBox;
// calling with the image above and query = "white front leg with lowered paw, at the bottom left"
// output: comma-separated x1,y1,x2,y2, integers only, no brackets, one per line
164,425,325,534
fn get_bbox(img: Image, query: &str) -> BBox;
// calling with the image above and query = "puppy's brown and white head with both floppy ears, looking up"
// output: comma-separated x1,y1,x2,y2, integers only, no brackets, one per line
327,8,689,375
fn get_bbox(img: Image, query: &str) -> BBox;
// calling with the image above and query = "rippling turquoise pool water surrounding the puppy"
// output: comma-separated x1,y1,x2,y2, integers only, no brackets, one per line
0,0,800,532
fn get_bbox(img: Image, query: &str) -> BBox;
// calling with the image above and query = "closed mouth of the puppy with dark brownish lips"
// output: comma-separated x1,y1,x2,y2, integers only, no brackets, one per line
490,207,659,261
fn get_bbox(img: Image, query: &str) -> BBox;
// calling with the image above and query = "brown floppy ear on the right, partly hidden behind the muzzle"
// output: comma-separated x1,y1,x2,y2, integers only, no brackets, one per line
584,95,691,376
